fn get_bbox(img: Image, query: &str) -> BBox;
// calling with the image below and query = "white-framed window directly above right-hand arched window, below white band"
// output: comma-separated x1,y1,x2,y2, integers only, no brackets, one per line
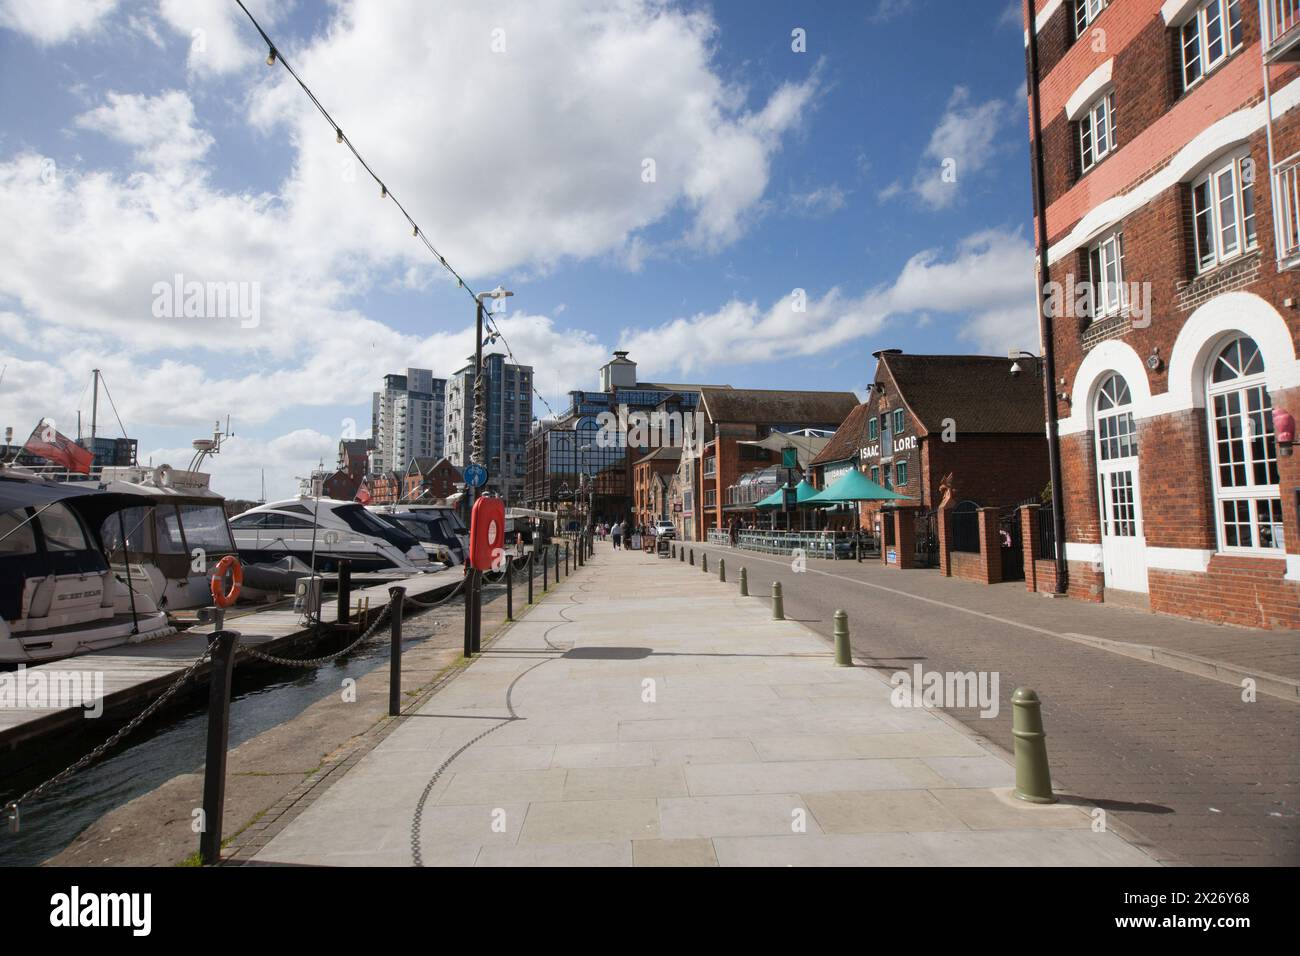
1192,152,1260,273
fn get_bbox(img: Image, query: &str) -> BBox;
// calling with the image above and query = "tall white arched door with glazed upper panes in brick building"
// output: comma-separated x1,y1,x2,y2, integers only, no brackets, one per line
1096,375,1148,592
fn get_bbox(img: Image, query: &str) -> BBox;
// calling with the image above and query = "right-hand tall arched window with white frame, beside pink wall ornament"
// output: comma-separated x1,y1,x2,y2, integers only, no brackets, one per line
1205,336,1283,551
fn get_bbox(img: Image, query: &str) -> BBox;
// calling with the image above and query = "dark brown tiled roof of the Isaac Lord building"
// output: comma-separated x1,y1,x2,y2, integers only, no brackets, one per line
868,352,1044,434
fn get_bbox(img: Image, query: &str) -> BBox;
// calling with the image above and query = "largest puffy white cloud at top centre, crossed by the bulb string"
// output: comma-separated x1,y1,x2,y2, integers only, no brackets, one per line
244,0,816,274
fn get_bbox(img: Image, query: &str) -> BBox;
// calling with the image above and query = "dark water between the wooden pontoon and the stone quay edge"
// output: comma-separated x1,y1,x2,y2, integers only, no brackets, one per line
0,614,447,866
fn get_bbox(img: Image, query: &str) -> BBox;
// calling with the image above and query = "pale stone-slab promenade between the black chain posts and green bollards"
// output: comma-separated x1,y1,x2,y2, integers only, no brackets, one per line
239,545,1153,866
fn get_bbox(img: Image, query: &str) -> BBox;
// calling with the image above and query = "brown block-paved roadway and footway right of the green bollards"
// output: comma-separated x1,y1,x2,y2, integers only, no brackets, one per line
694,544,1300,866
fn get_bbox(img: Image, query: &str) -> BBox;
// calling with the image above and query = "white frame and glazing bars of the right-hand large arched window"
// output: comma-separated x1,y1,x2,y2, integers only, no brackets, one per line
1205,333,1286,558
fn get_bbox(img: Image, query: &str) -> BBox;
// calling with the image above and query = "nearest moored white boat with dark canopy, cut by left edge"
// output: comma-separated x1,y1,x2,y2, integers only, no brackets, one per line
0,473,176,663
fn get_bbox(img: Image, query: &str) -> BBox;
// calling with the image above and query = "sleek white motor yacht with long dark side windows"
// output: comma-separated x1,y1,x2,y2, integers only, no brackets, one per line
230,498,437,574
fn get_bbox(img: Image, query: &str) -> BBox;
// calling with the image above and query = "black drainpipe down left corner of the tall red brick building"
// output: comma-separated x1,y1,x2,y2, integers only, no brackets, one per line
1024,0,1069,594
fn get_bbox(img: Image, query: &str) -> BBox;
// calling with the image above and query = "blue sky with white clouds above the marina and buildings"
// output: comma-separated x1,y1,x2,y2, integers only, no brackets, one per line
0,0,1037,498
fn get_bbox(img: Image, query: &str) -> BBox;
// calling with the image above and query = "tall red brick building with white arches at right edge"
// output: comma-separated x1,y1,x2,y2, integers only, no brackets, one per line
1026,0,1300,627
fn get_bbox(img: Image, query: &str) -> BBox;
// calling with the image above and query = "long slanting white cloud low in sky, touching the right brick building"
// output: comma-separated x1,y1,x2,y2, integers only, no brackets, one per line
620,230,1037,373
